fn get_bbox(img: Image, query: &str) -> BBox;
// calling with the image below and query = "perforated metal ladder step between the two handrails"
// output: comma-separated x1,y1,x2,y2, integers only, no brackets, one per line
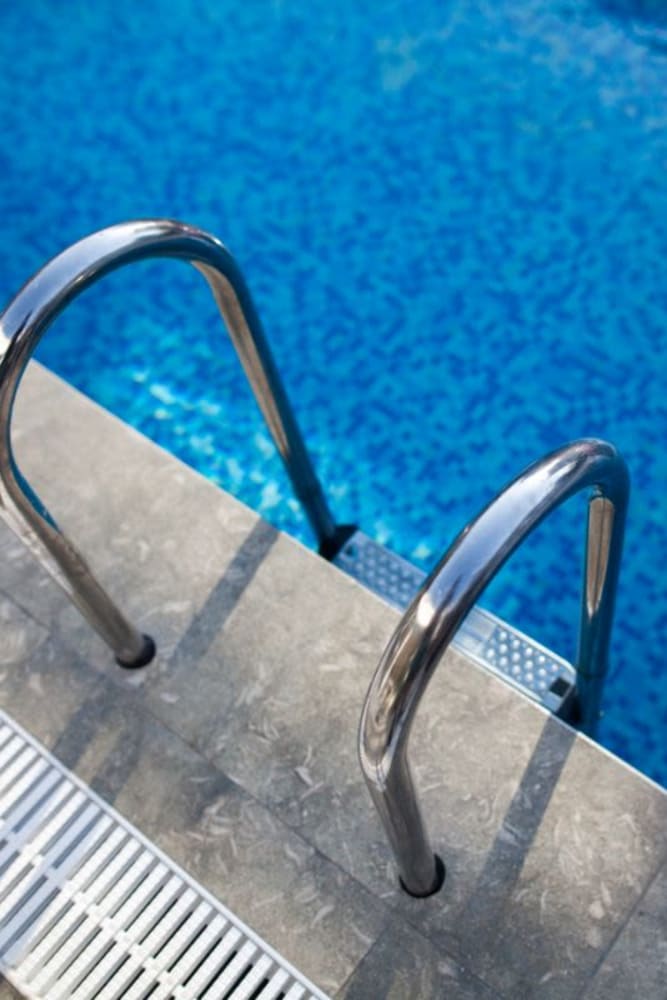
334,531,576,714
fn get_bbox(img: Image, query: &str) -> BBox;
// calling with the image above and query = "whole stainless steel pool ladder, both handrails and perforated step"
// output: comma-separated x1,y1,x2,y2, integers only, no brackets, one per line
0,219,628,896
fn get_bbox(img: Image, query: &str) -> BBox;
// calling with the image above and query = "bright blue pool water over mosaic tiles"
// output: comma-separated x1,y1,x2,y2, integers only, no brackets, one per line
0,0,667,783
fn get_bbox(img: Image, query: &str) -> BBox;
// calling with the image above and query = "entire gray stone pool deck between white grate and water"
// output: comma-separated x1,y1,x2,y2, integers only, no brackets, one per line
0,366,667,1000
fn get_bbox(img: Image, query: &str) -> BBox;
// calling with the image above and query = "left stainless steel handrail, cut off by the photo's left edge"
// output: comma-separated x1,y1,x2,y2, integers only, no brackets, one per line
0,219,345,666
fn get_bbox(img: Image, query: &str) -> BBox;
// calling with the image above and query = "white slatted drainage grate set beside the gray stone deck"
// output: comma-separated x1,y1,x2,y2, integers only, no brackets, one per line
0,711,327,1000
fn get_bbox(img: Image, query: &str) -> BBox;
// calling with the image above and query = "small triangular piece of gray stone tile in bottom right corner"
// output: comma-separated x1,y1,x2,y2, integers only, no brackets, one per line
583,865,667,1000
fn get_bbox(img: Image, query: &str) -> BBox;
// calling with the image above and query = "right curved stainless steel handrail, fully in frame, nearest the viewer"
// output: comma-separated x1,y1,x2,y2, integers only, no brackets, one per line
359,440,629,896
